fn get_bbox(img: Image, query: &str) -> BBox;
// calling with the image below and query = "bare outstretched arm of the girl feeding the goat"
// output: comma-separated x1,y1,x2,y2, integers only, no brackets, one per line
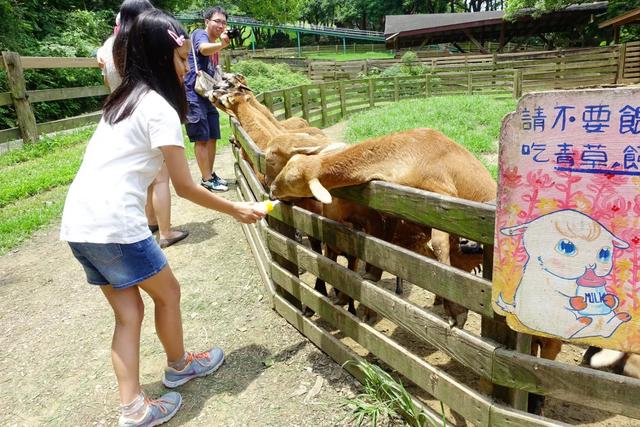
160,145,265,224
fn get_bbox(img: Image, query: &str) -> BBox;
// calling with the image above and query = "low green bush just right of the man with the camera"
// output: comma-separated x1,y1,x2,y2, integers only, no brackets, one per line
231,60,311,93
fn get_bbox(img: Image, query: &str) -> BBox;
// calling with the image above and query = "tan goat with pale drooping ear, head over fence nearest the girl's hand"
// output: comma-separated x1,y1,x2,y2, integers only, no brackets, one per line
271,129,496,326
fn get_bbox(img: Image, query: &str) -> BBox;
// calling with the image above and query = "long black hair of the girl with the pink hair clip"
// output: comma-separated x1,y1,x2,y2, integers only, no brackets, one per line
103,9,189,125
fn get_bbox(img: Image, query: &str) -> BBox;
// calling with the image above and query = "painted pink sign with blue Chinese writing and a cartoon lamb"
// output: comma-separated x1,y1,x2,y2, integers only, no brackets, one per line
492,88,640,352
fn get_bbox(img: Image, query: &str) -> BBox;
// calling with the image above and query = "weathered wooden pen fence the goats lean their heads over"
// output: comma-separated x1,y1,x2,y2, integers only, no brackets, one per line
231,81,640,427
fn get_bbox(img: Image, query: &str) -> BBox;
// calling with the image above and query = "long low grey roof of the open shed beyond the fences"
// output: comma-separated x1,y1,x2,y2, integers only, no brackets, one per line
384,1,608,47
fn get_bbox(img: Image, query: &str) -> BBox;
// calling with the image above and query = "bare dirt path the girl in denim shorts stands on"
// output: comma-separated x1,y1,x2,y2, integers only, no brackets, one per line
0,149,357,426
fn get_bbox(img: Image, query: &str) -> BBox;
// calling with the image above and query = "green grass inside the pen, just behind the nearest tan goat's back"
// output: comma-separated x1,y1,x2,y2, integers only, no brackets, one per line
345,95,516,177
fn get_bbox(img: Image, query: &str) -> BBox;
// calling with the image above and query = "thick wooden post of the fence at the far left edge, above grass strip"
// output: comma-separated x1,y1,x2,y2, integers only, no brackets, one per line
2,51,38,144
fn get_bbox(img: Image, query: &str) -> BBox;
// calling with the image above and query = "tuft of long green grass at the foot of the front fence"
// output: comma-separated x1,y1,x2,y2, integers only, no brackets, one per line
346,361,438,427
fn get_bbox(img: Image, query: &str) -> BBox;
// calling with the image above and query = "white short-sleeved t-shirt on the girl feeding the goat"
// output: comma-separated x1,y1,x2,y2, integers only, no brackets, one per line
60,91,184,243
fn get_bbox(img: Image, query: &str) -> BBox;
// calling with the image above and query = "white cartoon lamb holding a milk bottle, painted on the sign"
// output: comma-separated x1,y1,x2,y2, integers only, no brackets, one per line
496,209,631,339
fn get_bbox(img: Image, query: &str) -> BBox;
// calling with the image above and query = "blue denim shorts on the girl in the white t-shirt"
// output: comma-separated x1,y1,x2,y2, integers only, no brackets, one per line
69,237,167,289
